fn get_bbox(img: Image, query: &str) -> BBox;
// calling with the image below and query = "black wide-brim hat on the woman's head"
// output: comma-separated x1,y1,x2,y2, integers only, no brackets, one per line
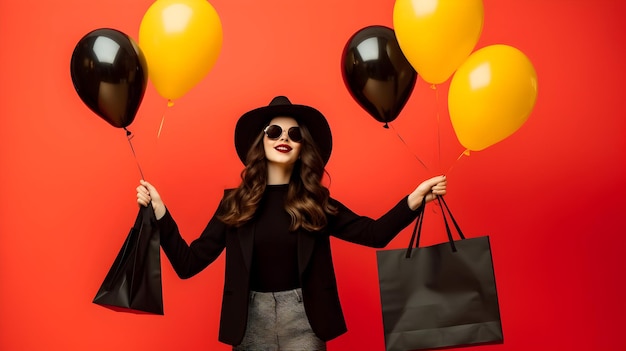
235,96,333,164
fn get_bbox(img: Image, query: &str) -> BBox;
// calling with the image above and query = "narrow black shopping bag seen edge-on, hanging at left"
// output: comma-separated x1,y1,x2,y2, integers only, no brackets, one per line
93,205,163,315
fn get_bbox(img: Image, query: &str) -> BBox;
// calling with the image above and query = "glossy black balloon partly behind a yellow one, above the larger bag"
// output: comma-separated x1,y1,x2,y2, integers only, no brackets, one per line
341,26,417,128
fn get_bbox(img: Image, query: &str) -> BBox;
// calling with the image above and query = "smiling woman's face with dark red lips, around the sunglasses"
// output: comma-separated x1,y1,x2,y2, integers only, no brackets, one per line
263,117,302,166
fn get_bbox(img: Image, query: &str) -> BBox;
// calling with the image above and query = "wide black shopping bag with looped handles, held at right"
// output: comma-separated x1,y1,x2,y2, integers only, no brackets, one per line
377,197,503,351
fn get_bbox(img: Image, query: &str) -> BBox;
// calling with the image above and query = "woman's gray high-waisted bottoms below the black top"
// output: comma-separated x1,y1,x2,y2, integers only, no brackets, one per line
233,289,326,351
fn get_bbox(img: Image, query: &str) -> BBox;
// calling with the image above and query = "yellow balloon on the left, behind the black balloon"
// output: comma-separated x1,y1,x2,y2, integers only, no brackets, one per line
139,0,223,102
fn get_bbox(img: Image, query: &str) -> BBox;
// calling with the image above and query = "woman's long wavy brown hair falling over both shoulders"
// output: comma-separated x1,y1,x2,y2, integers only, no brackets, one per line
218,124,337,231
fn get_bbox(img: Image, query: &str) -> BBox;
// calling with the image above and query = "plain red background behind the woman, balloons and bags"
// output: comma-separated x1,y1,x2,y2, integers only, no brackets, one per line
0,0,626,350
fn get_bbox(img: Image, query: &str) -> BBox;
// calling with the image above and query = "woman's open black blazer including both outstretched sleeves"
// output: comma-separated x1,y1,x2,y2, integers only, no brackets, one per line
158,191,421,345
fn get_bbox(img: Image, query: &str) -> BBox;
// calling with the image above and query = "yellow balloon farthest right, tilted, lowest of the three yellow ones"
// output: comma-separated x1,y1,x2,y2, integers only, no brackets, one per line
448,45,537,151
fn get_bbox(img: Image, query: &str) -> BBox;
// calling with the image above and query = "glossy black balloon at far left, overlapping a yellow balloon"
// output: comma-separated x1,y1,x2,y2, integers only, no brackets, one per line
70,28,148,128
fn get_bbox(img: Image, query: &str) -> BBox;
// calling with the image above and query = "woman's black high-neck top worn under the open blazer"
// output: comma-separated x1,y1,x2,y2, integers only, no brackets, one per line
250,184,300,292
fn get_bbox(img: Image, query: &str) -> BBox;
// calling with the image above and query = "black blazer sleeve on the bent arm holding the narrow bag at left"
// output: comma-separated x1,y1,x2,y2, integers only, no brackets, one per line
157,195,228,279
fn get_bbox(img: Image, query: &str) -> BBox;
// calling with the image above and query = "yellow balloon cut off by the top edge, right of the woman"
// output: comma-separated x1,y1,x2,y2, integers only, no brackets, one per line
393,0,484,84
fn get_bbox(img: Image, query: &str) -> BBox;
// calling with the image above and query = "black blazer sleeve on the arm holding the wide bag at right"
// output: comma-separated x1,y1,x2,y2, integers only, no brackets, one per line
328,196,424,248
